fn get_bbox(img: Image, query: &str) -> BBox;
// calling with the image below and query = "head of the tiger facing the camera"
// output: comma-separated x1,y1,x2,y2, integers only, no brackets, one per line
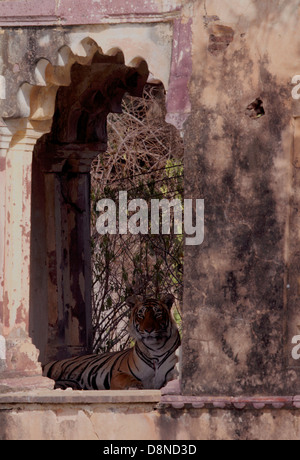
127,294,178,348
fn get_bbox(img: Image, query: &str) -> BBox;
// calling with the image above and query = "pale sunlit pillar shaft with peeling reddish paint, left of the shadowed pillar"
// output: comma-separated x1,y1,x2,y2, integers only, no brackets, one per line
3,126,40,373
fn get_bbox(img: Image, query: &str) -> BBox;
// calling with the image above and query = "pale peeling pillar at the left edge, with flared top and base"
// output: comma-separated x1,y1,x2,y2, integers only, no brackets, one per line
0,120,53,388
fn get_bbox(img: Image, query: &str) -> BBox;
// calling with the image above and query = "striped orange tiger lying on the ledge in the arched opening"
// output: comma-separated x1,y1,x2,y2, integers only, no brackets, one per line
43,294,181,390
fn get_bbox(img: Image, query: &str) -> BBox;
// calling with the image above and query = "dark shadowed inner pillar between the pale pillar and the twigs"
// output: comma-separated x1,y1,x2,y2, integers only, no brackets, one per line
31,142,106,362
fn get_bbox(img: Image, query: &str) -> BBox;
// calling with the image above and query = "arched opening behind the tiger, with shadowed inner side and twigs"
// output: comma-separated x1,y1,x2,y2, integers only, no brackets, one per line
29,45,183,370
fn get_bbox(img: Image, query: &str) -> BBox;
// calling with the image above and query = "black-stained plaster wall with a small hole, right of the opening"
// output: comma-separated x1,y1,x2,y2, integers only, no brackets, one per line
183,0,300,394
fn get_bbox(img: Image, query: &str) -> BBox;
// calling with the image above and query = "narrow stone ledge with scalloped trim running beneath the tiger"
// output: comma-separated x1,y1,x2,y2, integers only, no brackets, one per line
0,377,300,410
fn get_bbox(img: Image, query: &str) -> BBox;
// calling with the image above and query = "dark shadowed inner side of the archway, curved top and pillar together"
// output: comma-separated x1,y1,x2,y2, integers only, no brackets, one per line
30,52,149,362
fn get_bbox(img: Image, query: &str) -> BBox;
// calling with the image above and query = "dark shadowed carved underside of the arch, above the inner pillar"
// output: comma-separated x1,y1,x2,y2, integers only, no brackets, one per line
51,59,148,144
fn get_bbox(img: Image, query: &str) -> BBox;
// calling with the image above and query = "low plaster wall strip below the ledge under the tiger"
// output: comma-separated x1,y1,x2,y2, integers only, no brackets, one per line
0,390,300,440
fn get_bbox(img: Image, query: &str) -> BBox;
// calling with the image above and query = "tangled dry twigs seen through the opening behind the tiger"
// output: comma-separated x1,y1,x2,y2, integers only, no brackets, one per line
92,85,183,352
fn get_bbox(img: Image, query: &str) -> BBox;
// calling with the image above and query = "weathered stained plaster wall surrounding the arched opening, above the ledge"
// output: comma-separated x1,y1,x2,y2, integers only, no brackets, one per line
0,0,300,420
